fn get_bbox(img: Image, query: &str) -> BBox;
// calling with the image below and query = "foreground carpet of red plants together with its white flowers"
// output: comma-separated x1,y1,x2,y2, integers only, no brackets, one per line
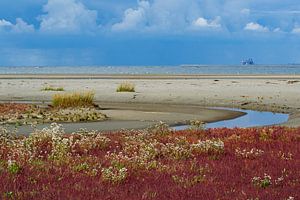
0,124,300,200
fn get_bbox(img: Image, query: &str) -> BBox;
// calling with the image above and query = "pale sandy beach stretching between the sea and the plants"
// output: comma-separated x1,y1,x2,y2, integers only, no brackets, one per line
0,75,300,129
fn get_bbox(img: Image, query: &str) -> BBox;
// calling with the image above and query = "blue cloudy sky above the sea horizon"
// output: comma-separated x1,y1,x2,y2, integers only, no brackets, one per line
0,0,300,66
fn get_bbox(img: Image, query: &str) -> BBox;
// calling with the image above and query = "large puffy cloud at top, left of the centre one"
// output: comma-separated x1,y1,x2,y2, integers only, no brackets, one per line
39,0,98,33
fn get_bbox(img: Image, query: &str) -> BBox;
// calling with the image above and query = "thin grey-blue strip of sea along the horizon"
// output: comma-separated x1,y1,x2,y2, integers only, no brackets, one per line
0,64,300,75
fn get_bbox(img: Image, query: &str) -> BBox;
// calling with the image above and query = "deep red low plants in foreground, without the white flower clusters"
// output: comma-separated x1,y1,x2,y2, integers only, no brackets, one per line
0,127,300,200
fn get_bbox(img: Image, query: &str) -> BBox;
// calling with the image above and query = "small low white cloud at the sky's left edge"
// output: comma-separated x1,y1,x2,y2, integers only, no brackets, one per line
0,18,34,33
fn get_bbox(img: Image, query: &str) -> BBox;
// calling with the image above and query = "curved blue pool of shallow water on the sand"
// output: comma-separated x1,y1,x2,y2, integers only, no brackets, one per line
174,108,289,130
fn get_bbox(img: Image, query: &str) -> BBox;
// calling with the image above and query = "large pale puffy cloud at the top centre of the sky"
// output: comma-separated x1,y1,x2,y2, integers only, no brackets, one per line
112,0,200,32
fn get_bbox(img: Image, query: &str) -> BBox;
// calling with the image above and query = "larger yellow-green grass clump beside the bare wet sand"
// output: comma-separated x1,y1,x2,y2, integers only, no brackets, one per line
52,91,95,108
